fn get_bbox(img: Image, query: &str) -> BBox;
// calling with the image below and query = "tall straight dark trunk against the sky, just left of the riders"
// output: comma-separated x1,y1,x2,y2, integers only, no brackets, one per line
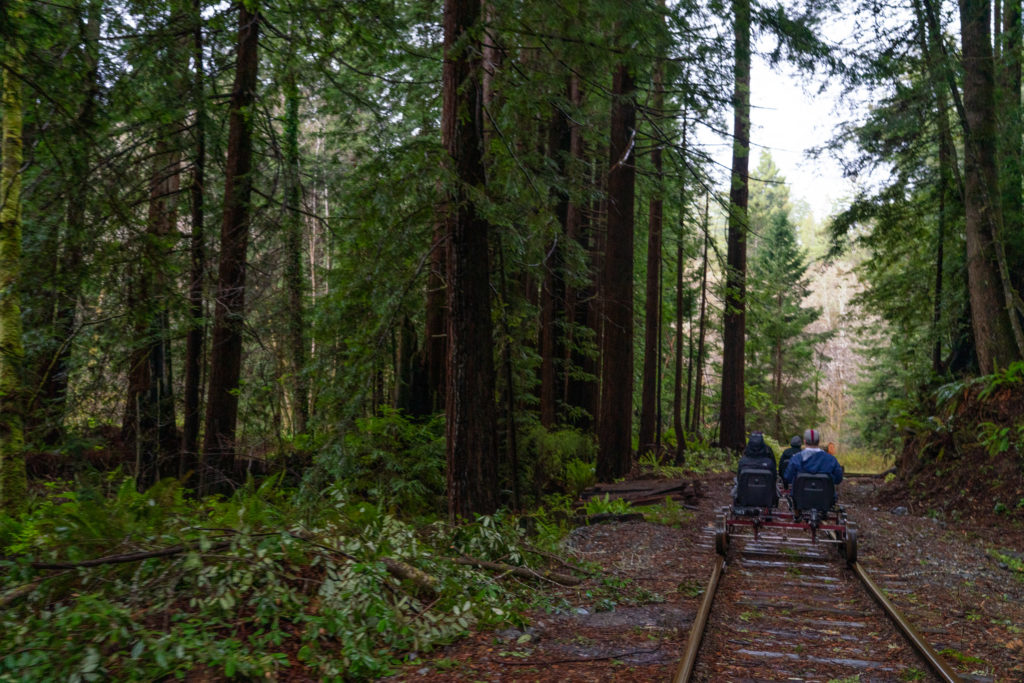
719,0,751,451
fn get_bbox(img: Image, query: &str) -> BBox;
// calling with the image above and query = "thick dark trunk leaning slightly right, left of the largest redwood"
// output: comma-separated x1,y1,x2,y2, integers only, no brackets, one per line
202,3,259,493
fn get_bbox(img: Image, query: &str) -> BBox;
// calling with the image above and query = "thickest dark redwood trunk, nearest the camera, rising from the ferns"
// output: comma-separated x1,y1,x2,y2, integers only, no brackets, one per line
441,0,498,520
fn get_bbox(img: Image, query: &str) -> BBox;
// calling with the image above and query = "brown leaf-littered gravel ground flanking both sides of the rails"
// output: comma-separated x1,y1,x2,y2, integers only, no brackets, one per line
387,474,1024,682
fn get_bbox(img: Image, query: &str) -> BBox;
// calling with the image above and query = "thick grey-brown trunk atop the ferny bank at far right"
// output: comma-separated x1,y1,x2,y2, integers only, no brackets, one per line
961,0,1019,374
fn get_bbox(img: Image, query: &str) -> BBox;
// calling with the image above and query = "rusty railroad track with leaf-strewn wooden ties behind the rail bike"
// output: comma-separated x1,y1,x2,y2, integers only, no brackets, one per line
673,531,961,683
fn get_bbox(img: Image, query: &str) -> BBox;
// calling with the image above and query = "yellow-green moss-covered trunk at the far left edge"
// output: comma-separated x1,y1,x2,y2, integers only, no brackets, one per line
0,0,28,513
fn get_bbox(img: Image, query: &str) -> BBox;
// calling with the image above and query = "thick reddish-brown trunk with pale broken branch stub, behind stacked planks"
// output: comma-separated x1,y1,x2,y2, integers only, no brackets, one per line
597,65,636,481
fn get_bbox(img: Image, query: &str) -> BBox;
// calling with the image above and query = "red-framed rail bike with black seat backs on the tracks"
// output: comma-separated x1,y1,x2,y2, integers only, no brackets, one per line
715,469,857,565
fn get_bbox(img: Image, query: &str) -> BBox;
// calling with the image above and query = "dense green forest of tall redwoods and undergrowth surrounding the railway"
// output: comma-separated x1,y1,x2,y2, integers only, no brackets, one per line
0,0,1024,679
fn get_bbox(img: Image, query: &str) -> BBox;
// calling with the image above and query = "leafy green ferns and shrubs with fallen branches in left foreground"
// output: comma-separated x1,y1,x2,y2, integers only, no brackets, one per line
0,478,552,681
